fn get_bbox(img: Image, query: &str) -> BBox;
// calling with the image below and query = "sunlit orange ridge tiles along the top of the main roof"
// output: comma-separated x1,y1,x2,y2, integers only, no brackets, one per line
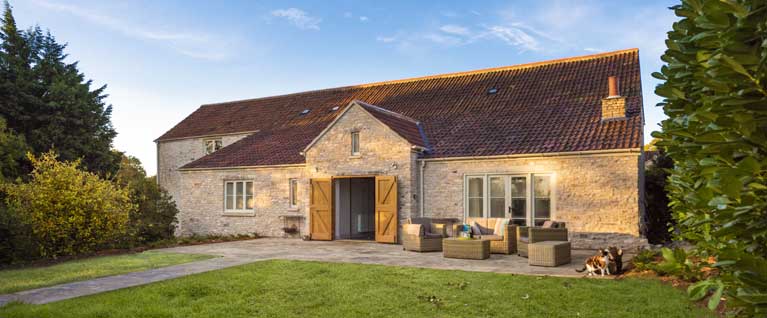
200,48,639,107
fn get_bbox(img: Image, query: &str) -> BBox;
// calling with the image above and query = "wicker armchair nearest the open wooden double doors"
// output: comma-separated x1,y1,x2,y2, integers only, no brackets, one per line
402,219,447,252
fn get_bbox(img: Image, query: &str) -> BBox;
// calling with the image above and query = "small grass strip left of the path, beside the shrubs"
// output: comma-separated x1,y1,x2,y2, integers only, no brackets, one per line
0,251,213,294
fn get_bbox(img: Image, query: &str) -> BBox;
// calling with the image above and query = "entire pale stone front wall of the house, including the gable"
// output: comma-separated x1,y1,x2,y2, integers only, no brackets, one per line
158,105,646,249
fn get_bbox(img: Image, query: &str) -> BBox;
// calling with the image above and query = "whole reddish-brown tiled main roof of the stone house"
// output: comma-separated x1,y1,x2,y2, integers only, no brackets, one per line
166,49,643,168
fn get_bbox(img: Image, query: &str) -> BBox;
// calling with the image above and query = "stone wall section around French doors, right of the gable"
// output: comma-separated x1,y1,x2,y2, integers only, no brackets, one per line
423,152,646,248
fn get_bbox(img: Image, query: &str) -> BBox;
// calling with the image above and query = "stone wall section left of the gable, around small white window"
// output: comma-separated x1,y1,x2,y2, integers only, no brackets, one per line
176,166,309,236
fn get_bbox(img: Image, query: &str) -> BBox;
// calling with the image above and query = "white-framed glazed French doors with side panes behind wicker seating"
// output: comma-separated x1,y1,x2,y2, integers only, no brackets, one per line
464,173,555,226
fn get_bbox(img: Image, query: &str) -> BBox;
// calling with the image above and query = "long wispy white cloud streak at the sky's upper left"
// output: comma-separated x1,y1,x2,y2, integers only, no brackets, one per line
32,0,230,60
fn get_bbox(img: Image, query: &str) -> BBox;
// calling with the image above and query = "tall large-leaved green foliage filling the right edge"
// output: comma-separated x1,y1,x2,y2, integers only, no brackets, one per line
653,0,767,317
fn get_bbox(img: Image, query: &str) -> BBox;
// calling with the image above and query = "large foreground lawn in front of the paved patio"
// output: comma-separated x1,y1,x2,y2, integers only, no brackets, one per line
0,260,713,318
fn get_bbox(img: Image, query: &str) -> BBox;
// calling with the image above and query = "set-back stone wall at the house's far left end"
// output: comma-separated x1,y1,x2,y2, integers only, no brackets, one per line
157,134,254,210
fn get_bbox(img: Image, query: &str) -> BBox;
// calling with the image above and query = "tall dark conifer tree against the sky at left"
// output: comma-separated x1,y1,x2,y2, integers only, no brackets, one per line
0,2,120,176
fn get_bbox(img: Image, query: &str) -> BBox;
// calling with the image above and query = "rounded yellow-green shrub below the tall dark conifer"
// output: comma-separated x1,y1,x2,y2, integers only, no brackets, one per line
3,152,135,258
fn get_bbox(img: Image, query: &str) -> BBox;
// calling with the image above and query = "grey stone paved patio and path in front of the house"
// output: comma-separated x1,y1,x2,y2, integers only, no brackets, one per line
0,238,616,306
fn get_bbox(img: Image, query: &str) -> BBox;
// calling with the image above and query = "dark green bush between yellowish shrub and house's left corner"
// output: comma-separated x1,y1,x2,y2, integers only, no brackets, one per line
115,155,178,244
